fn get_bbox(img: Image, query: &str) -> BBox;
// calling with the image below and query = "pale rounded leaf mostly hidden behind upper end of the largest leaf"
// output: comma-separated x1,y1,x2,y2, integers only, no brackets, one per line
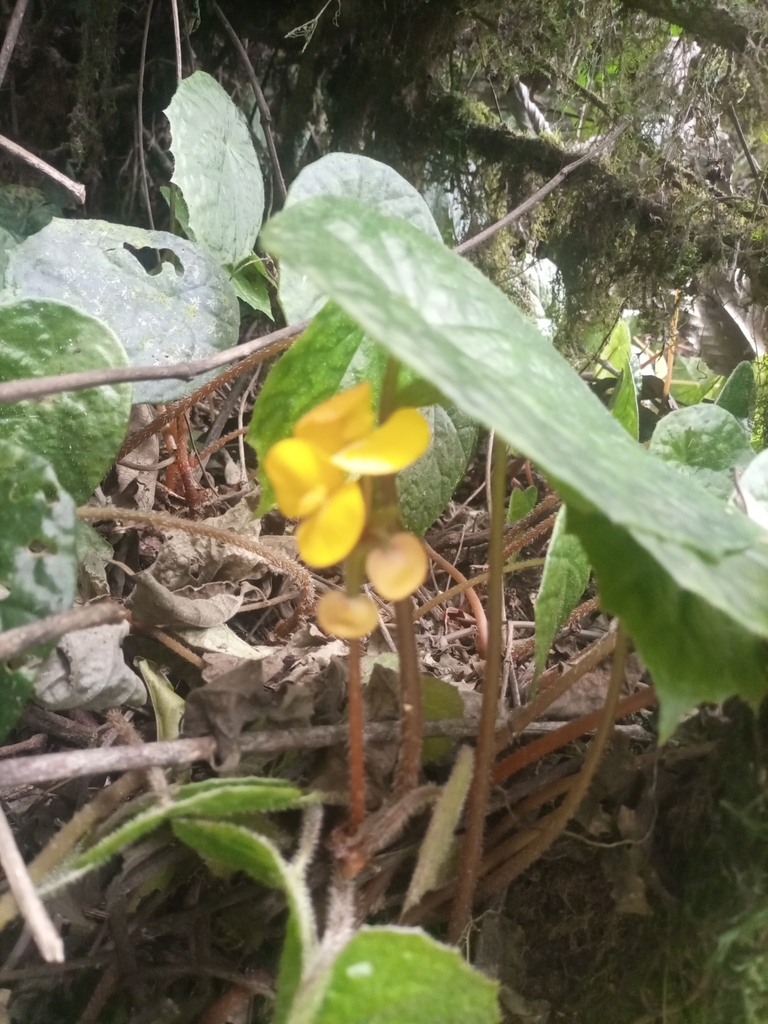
280,153,440,324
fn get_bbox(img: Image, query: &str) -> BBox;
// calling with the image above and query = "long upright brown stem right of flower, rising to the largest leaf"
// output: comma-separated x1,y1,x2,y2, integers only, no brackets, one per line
447,436,507,943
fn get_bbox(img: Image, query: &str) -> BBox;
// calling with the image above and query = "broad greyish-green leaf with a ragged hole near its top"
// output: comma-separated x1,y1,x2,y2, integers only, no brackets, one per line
0,218,240,402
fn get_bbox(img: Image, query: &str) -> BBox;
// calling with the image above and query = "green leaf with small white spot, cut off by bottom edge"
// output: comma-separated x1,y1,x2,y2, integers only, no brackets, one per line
313,928,501,1024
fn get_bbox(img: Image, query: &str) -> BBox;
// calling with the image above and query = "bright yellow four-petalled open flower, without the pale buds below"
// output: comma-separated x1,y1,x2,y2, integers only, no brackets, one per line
264,383,429,568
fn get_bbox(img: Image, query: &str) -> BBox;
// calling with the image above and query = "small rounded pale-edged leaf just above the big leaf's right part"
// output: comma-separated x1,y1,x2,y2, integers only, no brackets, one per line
649,406,755,501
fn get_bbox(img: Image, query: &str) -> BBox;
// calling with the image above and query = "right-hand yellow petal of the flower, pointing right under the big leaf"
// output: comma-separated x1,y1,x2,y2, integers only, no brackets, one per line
332,409,429,476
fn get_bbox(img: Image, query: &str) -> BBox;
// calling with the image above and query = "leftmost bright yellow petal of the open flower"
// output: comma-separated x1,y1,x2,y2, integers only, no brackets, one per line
264,437,344,519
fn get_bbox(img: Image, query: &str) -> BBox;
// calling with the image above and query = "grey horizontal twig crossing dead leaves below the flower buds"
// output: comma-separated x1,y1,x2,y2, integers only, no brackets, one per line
0,718,507,790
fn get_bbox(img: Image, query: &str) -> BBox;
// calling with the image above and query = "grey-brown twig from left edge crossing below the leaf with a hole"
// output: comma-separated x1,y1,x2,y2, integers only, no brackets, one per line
0,319,309,402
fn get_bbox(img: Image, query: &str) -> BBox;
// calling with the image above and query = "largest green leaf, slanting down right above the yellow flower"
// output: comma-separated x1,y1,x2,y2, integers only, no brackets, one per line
263,200,768,726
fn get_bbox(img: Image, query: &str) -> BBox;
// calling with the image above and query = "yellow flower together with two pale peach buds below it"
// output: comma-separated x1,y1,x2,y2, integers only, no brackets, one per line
264,383,429,637
